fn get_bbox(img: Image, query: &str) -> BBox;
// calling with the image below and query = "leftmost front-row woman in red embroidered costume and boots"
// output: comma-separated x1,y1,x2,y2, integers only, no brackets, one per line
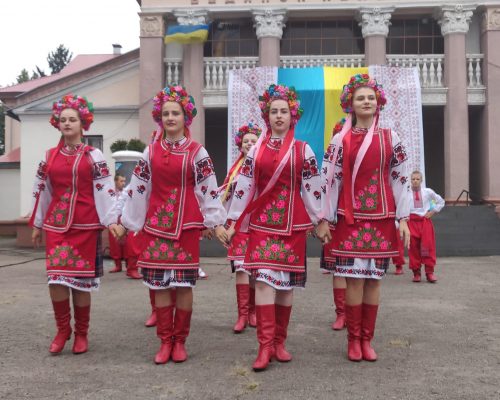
30,94,118,354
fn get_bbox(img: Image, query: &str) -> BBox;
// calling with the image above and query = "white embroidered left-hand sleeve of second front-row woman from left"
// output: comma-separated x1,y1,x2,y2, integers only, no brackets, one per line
121,146,151,232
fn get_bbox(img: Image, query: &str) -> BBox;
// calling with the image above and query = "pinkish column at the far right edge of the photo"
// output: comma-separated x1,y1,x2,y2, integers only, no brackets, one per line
479,8,500,205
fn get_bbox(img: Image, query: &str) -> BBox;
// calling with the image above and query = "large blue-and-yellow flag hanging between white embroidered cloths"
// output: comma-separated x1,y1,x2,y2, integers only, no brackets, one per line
277,67,368,164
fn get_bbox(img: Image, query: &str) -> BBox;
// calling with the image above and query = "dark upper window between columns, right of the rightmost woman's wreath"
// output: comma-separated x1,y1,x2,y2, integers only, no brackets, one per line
387,17,444,54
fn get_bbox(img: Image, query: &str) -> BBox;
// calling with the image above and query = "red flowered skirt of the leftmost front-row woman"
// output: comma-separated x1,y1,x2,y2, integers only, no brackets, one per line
46,229,99,278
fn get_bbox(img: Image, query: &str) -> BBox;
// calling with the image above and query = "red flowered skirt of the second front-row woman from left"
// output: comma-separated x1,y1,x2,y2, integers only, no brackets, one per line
137,229,200,269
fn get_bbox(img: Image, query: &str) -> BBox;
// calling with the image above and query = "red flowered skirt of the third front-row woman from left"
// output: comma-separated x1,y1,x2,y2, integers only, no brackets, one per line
243,230,306,272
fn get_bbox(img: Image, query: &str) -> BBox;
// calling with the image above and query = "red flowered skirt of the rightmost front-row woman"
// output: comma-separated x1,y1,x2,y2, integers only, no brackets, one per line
324,215,399,262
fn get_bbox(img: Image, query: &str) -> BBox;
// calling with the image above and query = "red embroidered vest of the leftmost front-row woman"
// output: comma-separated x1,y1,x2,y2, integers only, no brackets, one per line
43,145,102,233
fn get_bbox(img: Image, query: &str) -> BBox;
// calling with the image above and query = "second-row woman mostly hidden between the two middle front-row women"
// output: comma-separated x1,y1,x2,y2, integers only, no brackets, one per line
220,123,262,333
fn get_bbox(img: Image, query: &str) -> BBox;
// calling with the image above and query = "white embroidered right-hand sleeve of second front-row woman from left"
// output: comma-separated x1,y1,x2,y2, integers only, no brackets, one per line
193,147,226,228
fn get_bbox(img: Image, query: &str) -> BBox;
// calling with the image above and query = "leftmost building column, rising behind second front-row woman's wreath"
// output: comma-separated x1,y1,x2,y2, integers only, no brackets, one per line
139,14,165,143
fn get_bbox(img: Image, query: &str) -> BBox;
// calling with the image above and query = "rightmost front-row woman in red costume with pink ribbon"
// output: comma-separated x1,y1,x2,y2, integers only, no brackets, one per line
317,74,410,361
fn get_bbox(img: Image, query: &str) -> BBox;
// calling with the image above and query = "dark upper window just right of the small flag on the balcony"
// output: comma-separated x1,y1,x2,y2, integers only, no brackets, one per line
203,20,259,57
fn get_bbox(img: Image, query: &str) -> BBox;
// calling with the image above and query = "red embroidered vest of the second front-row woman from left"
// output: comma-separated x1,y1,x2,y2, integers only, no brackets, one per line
144,139,204,239
